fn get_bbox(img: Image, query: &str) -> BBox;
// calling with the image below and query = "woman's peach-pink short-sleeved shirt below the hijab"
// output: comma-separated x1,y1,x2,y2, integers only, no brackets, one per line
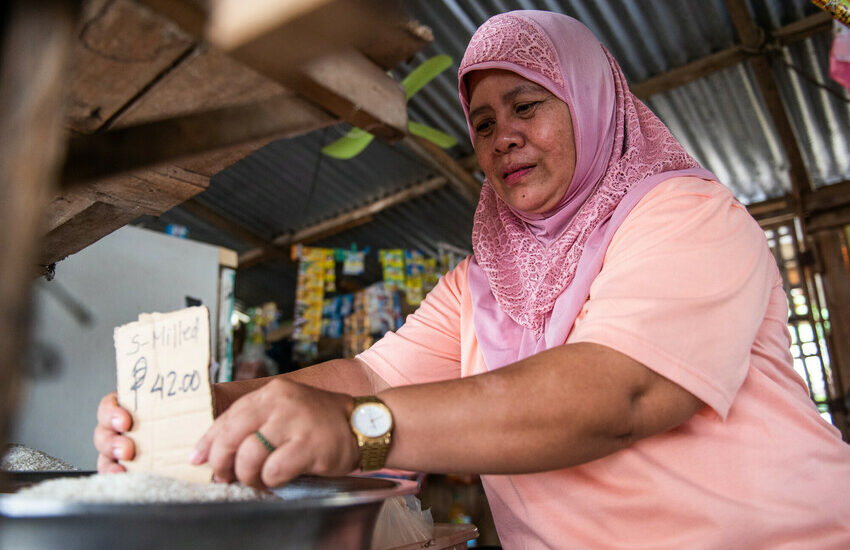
359,178,850,550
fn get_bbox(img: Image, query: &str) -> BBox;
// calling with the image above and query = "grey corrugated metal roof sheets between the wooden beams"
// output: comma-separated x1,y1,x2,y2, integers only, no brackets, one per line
141,0,850,311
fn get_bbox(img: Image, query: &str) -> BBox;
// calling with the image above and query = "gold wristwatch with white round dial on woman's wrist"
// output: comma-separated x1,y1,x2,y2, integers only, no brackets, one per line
349,395,393,472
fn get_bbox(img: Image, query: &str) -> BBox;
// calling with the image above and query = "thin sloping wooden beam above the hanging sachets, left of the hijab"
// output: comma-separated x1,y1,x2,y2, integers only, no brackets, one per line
239,176,448,269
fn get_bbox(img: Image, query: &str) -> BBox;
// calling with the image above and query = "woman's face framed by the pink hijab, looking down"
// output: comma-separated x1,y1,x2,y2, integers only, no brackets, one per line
466,69,576,214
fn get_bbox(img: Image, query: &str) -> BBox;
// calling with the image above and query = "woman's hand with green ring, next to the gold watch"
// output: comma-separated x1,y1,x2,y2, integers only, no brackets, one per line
190,378,360,488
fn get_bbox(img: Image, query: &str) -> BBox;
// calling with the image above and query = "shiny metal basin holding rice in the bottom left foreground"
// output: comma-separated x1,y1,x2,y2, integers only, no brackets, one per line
0,474,418,550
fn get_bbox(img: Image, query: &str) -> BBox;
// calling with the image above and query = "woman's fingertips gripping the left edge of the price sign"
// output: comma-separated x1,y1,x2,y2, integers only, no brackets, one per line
94,392,136,474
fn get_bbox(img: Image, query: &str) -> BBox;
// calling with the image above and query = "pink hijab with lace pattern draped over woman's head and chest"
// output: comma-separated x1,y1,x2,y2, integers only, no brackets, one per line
458,10,716,370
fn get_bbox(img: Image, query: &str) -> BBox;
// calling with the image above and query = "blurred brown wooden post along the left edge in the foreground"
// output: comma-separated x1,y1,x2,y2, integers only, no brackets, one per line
0,0,78,458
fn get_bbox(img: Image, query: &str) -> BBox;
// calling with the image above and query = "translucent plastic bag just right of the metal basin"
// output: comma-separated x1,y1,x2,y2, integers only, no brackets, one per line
371,495,434,550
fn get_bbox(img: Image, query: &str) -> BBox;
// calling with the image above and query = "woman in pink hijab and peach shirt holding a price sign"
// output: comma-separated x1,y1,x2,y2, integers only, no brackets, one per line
95,11,850,549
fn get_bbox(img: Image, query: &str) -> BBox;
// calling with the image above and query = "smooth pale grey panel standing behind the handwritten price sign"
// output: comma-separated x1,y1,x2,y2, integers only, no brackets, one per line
10,226,219,470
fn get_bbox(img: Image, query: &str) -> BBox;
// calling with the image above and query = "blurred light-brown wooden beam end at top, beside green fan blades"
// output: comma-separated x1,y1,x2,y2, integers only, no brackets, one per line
145,0,418,141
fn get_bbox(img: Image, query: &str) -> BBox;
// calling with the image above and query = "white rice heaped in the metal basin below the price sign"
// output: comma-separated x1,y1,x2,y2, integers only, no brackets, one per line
10,472,278,504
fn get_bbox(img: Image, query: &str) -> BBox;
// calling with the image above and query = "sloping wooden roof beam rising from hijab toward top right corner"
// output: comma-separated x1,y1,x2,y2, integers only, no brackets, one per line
629,11,831,99
